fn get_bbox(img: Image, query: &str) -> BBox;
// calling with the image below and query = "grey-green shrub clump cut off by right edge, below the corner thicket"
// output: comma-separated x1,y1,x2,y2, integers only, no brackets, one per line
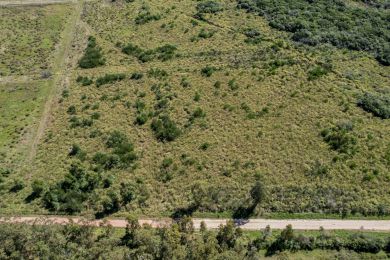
358,92,390,119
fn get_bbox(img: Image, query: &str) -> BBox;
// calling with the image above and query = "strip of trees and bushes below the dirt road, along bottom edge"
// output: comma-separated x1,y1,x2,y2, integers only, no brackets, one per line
0,218,390,259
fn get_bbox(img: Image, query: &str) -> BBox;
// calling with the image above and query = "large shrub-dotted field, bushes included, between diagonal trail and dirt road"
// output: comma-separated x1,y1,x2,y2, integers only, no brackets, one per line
3,0,390,216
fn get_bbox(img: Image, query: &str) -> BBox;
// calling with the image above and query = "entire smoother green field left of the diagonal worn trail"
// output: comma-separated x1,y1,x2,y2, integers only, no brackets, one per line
0,5,73,200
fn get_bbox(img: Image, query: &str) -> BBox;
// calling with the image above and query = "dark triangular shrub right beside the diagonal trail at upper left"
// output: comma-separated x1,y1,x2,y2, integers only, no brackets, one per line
79,36,106,69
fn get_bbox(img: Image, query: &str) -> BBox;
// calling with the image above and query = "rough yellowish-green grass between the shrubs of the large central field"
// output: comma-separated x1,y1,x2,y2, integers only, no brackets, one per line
4,0,390,218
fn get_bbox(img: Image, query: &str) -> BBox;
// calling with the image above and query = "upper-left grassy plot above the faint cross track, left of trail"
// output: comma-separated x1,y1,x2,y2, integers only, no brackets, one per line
0,5,71,76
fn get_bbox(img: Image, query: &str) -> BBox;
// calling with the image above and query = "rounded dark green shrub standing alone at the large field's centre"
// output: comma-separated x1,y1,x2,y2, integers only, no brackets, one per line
151,115,181,142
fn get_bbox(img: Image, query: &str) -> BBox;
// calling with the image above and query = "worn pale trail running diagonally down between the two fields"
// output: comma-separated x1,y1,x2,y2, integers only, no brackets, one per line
25,0,83,179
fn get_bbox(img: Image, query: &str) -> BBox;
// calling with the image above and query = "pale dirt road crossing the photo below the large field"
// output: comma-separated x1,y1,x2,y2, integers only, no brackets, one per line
0,216,390,231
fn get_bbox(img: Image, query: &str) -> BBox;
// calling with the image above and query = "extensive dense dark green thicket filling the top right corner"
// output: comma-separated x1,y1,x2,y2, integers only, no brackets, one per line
237,0,390,65
